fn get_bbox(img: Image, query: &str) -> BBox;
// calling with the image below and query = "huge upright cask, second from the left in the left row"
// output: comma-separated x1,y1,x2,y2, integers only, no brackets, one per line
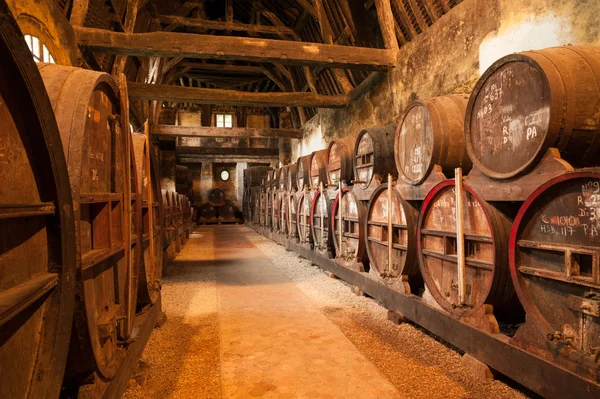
38,64,138,379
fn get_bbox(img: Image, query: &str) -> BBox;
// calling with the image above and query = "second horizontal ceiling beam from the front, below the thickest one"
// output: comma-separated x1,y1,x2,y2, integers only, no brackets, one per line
129,82,348,108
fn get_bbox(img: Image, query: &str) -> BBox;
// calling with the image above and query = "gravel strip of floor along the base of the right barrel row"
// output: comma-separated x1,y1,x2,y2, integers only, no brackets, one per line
248,228,528,399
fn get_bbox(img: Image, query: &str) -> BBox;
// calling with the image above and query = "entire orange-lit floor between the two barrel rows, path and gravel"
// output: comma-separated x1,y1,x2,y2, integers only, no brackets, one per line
125,225,524,398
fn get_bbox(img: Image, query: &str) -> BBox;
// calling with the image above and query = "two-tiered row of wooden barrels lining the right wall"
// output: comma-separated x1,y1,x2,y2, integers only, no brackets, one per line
246,46,600,390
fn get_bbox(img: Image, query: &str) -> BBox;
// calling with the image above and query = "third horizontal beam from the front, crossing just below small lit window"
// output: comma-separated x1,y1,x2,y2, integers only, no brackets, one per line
150,125,303,139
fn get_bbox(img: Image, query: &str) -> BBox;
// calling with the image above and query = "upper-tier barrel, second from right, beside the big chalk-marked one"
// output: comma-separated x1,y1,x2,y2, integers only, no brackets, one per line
395,94,471,186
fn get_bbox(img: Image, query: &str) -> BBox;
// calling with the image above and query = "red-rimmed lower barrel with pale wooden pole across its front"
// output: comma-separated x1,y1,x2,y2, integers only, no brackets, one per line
417,180,514,316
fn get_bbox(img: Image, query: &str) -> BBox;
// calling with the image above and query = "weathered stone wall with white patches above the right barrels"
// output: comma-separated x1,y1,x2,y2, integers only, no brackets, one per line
292,0,600,161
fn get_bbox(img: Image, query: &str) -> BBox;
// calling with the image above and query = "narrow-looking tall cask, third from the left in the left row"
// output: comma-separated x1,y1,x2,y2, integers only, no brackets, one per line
131,133,164,305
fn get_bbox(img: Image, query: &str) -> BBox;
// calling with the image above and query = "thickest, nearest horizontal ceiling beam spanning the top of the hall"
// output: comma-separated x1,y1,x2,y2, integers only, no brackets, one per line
74,27,398,70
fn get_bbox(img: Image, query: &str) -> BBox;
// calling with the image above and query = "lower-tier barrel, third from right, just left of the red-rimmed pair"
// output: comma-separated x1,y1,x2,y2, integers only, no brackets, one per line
366,184,422,293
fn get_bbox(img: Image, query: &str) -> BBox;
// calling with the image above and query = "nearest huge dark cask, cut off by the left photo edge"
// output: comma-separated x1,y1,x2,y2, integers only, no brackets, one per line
0,5,76,398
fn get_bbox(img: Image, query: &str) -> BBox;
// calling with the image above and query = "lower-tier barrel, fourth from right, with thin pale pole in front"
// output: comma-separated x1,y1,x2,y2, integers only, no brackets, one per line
331,187,369,272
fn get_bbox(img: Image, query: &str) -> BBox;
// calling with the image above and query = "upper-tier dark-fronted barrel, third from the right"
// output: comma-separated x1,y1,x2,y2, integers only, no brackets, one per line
353,125,398,190
